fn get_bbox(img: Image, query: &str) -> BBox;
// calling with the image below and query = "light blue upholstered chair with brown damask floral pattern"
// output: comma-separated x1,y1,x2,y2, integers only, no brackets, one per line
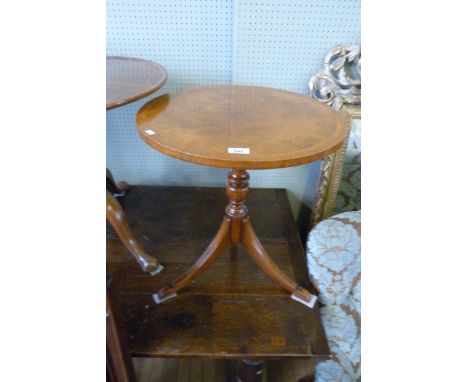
307,211,361,382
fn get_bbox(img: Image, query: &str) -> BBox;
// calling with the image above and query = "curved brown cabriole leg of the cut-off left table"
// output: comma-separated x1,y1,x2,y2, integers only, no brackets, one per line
106,191,163,275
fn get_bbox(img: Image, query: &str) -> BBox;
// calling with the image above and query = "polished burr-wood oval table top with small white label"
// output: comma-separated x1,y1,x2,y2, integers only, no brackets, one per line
136,86,346,169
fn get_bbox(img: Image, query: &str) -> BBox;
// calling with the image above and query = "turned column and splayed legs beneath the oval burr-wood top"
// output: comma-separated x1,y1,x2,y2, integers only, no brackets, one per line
153,169,317,308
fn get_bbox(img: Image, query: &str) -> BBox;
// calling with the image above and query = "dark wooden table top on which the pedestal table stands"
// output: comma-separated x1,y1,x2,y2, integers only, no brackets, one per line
107,186,329,359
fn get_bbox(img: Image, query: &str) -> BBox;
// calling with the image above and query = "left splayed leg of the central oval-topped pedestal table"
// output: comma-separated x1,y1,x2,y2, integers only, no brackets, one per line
153,218,229,304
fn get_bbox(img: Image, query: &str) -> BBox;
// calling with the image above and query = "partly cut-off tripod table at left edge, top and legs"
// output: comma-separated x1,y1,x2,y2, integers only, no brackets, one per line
106,56,167,275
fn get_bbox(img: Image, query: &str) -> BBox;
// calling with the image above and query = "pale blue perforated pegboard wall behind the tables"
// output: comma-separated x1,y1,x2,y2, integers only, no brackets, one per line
107,0,360,225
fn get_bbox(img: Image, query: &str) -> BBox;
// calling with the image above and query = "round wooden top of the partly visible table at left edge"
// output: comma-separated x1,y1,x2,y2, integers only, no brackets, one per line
106,56,167,110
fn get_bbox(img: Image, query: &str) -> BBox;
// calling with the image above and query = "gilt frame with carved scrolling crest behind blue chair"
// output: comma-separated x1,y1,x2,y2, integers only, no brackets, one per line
309,45,361,226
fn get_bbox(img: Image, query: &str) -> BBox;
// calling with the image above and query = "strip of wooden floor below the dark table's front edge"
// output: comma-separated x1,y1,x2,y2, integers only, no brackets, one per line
133,358,314,382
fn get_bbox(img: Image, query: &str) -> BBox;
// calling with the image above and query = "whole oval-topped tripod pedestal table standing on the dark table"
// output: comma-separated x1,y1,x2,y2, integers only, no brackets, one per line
137,86,346,307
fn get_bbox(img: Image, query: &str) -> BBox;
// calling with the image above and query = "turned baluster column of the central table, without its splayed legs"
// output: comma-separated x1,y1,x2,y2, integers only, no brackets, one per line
225,170,249,244
